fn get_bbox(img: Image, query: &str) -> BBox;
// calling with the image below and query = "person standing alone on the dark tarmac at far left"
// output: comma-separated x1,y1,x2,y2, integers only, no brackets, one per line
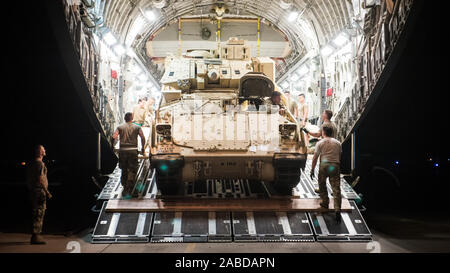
27,145,51,244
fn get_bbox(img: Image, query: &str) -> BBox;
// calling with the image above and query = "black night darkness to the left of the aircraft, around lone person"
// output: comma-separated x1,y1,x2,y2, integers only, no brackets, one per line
0,1,108,233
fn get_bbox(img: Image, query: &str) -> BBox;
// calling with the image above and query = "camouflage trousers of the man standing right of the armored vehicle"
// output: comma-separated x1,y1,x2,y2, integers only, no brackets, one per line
318,162,342,211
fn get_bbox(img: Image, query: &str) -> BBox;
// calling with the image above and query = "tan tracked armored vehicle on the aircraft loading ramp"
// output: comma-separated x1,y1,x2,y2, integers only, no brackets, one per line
150,38,306,195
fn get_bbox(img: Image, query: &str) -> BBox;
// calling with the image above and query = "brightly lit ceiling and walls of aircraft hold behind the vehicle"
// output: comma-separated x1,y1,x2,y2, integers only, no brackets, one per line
64,0,413,144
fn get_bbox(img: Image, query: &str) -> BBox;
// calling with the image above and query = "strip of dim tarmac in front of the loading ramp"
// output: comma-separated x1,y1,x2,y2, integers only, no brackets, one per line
0,226,450,253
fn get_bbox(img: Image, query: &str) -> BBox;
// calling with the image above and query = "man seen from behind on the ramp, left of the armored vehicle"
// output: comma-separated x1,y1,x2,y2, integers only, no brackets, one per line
113,112,145,199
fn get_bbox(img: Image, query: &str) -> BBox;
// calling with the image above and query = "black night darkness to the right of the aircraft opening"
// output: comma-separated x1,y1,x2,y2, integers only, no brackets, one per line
356,1,450,213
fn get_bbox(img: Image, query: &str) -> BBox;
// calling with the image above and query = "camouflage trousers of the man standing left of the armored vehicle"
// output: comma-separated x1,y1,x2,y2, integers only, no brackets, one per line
119,150,138,196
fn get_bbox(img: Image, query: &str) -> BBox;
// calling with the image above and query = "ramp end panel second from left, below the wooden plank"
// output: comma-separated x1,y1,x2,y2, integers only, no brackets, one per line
151,211,232,242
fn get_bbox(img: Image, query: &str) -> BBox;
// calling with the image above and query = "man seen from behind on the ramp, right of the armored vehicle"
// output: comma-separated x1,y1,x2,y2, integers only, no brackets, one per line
311,125,342,222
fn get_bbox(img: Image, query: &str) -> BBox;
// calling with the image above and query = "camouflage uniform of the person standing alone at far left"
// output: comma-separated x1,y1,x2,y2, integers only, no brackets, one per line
27,160,48,234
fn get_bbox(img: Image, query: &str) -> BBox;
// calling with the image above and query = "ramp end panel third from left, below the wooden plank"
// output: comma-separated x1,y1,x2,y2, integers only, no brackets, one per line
232,209,314,242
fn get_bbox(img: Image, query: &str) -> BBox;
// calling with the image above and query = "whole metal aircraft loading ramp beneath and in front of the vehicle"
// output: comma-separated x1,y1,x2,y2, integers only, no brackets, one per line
92,161,372,243
